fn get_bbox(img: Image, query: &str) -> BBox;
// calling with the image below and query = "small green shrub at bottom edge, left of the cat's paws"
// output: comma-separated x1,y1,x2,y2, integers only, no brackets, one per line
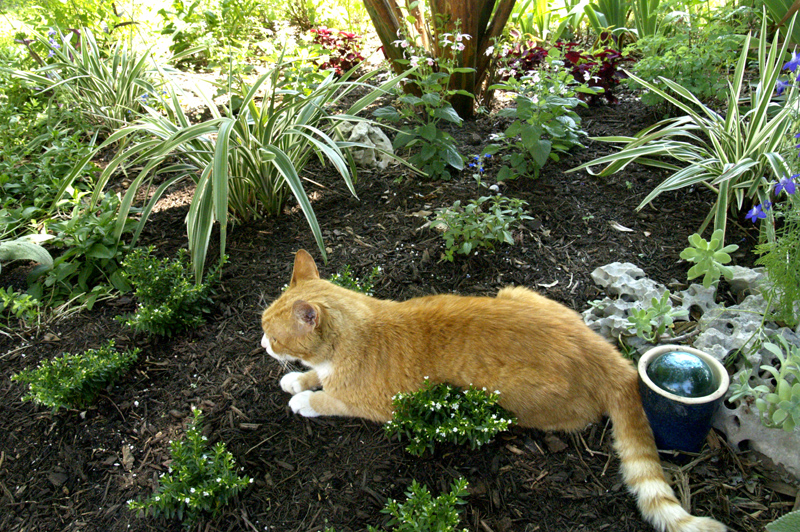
128,408,253,529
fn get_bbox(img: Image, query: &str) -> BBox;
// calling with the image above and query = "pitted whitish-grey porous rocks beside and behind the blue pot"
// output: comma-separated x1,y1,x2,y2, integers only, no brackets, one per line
583,262,800,478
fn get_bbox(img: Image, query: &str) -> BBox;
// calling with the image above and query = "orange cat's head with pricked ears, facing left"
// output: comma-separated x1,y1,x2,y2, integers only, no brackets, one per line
261,249,330,366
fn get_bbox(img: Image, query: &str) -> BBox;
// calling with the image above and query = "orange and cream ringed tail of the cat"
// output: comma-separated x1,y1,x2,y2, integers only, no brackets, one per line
608,374,726,532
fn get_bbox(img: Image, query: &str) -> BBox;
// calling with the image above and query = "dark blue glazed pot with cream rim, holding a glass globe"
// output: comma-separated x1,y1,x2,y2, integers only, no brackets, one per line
638,345,730,453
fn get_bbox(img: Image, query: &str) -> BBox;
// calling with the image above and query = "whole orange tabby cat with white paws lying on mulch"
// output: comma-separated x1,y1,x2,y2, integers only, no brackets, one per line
261,250,725,532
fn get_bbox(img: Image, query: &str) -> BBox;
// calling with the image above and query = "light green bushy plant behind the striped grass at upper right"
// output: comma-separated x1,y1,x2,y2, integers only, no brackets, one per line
626,6,747,105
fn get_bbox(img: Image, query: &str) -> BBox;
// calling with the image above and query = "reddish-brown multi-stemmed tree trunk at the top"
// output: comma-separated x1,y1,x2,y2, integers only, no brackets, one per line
364,0,516,118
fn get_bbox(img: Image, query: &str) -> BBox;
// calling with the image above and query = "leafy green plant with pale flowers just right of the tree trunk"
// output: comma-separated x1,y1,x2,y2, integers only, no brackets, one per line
485,49,593,181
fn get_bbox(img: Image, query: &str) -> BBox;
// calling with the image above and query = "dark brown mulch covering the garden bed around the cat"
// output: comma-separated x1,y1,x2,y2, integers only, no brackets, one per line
0,91,798,532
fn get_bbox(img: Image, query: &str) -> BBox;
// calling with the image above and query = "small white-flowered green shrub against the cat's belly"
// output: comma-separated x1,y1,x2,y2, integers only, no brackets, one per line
384,378,515,456
